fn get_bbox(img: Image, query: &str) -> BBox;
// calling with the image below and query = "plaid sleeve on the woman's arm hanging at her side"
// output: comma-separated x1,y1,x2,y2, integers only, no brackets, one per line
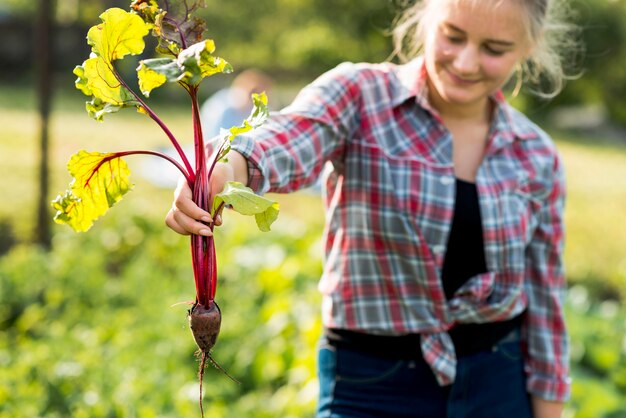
524,156,571,401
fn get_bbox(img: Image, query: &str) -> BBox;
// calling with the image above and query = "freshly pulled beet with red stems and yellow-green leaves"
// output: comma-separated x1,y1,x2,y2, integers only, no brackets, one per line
52,0,279,414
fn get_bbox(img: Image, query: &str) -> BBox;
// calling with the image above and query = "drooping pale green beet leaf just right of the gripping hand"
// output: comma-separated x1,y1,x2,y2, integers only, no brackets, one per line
213,181,279,232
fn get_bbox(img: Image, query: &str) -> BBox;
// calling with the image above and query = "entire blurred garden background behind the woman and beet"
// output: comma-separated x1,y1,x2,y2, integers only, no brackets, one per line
0,0,626,418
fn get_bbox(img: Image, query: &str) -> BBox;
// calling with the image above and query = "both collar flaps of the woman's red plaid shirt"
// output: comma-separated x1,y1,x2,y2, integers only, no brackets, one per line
393,55,537,140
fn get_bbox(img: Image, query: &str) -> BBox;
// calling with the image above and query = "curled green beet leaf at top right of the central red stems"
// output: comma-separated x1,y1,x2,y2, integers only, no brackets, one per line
178,39,233,86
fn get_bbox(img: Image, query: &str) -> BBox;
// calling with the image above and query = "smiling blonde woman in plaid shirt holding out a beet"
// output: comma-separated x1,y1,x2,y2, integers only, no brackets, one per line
166,0,570,418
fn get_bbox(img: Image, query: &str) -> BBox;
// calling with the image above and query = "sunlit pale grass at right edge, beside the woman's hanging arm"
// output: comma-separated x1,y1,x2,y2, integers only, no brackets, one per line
558,137,626,298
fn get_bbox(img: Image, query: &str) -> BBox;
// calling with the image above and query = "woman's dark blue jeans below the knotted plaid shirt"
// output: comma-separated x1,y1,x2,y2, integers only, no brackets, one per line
316,339,532,418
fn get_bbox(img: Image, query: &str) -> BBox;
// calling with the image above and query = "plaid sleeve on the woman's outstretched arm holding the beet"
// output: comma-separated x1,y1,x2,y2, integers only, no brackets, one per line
231,63,360,193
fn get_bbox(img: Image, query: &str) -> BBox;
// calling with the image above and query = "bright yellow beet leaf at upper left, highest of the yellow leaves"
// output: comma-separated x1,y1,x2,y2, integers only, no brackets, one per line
87,7,150,62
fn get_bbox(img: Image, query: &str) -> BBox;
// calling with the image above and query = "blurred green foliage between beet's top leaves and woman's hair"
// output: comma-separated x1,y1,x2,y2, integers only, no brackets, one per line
197,0,397,78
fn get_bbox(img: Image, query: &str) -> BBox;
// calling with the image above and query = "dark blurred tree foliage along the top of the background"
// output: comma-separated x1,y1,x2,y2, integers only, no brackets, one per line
0,0,626,125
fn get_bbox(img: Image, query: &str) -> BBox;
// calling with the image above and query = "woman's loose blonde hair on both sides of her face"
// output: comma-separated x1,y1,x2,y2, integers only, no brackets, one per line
391,0,582,98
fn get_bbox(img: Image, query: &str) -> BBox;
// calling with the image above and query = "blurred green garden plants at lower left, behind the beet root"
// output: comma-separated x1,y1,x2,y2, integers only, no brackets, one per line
0,198,321,418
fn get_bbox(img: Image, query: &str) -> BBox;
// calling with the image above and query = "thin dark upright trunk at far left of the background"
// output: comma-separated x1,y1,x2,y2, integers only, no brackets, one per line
34,0,54,249
